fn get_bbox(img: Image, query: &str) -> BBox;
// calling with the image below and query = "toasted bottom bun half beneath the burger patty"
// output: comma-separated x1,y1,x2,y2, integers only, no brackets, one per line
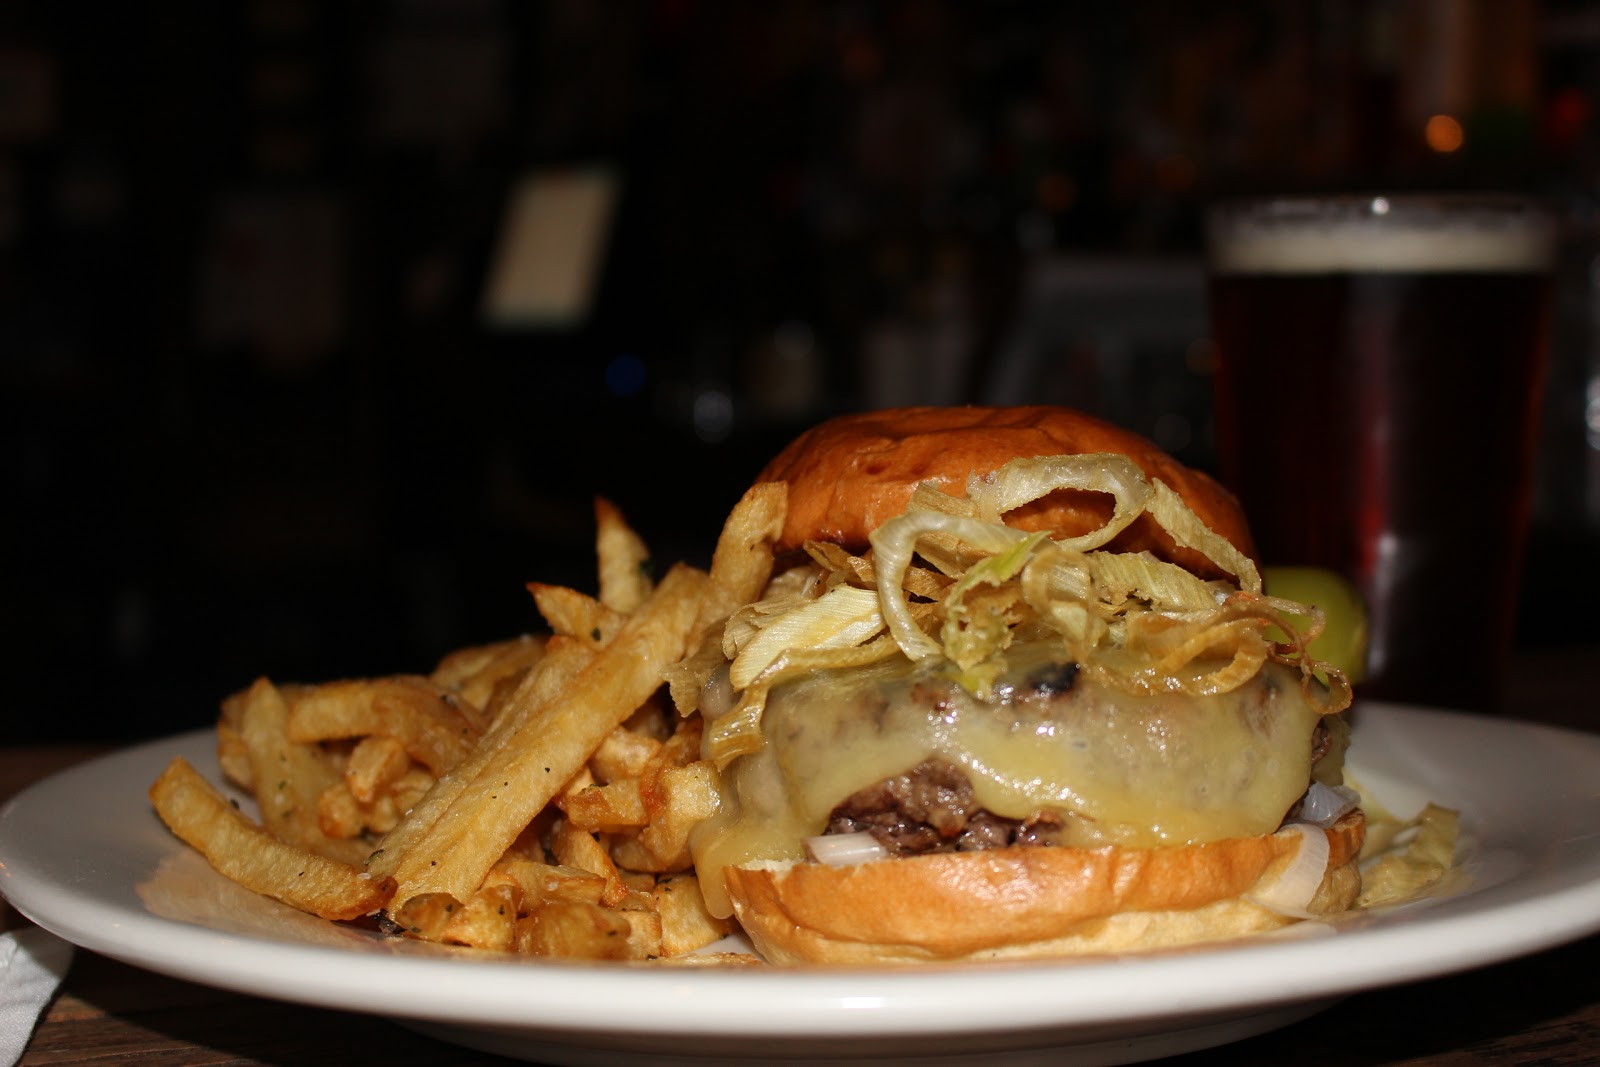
725,811,1366,963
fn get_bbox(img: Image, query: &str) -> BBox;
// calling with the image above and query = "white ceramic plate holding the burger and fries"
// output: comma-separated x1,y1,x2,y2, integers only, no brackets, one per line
0,704,1600,1065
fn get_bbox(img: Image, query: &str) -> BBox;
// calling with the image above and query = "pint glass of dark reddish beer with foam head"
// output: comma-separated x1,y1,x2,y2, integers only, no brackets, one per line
1206,195,1557,710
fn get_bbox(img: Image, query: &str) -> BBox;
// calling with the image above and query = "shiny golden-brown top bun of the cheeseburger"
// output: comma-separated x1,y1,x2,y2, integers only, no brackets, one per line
757,405,1254,577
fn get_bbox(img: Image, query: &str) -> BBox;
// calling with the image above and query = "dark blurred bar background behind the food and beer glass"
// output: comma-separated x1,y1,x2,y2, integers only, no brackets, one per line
0,0,1600,741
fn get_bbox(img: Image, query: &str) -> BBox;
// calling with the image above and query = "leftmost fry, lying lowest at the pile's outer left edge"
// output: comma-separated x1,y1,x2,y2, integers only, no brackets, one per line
150,757,394,920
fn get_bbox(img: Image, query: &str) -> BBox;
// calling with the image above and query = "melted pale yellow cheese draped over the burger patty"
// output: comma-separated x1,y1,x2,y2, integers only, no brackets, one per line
693,646,1320,915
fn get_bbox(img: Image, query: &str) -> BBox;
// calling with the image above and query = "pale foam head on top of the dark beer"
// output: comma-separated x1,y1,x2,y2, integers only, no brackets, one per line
1208,197,1555,274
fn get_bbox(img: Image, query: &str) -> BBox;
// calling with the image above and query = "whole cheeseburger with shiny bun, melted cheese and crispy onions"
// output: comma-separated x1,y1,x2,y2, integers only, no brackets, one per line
675,406,1365,963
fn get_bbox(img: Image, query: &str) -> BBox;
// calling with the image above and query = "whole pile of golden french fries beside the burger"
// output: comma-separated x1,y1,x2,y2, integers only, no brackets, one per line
150,483,787,961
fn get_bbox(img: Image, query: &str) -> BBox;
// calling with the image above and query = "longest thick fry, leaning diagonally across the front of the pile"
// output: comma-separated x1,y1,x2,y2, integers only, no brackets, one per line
384,563,706,901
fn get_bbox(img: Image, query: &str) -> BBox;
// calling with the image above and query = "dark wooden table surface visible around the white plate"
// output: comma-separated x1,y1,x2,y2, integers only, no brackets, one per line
0,648,1600,1067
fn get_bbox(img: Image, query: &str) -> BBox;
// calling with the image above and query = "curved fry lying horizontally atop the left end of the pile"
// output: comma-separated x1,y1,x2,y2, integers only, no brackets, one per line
286,675,478,774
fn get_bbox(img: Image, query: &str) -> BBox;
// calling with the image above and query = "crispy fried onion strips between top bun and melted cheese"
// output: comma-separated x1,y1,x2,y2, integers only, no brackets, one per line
706,453,1350,765
